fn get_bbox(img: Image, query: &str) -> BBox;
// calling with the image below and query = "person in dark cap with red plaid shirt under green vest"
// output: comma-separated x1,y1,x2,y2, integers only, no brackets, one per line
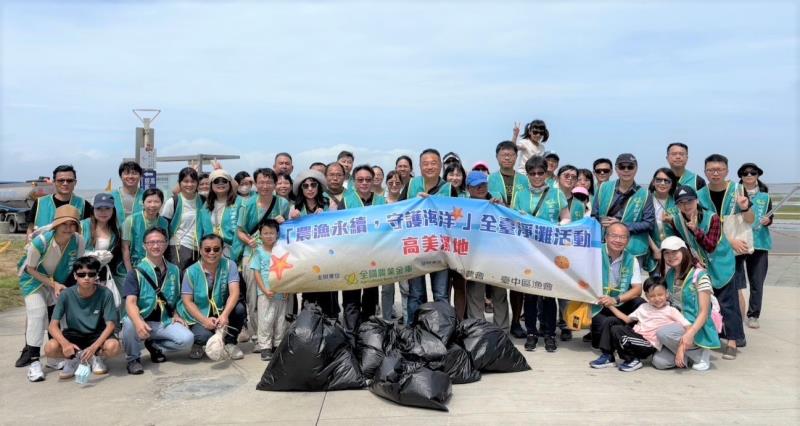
670,185,753,359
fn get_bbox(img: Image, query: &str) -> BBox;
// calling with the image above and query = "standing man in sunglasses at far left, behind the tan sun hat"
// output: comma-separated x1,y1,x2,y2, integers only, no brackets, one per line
25,164,92,240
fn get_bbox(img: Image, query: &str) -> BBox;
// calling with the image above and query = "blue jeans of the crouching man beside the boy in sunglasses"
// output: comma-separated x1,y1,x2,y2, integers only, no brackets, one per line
122,318,194,362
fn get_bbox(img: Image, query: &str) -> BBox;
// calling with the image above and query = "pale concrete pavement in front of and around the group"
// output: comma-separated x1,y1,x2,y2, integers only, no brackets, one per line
0,256,800,426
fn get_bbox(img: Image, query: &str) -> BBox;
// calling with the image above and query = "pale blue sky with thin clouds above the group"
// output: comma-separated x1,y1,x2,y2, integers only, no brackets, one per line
0,1,800,187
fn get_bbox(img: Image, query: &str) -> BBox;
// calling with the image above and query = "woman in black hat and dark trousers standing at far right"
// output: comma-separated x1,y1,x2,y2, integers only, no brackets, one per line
736,163,772,328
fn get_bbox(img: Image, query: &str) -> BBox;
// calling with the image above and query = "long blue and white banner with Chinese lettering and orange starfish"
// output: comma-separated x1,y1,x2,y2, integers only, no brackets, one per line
269,197,603,302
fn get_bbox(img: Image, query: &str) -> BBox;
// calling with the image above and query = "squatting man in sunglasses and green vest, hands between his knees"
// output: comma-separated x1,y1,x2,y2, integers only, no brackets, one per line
178,234,247,359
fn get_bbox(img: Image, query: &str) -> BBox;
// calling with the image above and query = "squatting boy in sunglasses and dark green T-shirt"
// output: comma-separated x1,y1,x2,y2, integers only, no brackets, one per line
44,256,120,379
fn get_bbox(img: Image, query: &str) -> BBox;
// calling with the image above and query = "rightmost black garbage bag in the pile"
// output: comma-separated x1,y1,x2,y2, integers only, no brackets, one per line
456,319,531,373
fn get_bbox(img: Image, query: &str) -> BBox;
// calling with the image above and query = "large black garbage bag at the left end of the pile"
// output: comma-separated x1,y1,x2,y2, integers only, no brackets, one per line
256,306,366,391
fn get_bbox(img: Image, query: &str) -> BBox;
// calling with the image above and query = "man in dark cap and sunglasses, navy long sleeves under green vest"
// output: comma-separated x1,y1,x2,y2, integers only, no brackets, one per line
592,154,656,257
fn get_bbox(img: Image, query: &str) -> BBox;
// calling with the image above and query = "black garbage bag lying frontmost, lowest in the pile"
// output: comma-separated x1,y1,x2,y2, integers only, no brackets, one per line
369,352,452,411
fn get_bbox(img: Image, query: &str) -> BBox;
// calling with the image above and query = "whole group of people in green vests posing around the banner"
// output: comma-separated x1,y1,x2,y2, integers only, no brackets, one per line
16,120,772,382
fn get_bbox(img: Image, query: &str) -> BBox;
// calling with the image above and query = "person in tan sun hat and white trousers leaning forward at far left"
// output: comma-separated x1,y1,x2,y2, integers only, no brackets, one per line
15,204,85,382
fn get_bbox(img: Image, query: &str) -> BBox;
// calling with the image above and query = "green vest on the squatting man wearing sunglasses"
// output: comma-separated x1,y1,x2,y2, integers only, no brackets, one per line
178,256,230,325
